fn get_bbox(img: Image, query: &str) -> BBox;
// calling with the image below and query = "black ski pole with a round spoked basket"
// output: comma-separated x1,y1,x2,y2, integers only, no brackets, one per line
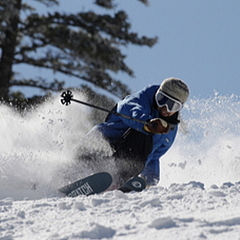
61,90,149,124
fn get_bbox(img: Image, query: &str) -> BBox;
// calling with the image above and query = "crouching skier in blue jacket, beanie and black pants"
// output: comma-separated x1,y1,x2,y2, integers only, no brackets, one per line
84,78,189,187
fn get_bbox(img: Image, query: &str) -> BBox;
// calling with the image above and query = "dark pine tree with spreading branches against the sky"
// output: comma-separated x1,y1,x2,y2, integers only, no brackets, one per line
0,0,157,101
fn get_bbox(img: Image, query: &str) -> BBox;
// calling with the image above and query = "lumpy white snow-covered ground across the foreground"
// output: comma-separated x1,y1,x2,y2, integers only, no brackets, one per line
0,184,240,240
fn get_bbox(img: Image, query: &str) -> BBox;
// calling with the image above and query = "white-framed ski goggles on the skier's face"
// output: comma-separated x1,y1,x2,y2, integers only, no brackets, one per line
155,91,183,112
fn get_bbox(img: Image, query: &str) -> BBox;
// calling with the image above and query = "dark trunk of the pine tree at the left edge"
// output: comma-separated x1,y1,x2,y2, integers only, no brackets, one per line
0,0,22,101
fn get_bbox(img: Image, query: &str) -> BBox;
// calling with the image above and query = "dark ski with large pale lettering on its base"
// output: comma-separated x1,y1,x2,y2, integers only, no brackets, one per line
58,172,112,197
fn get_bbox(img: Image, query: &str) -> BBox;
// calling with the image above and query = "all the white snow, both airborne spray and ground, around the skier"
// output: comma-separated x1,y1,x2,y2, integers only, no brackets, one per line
0,91,240,240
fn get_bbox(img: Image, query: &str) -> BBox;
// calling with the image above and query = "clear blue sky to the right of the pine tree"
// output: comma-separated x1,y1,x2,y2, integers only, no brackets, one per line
18,0,240,98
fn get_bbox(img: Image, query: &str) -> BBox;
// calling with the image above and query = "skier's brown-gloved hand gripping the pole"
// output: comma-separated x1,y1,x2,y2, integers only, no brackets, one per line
144,118,170,134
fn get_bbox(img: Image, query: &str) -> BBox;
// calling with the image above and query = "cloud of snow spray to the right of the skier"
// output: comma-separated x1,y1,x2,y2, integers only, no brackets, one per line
160,93,240,186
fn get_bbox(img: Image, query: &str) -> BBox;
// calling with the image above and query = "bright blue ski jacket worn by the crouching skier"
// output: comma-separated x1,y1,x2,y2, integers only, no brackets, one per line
90,85,178,185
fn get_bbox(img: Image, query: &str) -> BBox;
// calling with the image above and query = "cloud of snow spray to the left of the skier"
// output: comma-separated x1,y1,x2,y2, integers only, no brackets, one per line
0,93,109,199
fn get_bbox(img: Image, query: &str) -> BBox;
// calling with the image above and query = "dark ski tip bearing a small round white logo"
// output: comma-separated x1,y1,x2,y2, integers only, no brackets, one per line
118,177,146,193
